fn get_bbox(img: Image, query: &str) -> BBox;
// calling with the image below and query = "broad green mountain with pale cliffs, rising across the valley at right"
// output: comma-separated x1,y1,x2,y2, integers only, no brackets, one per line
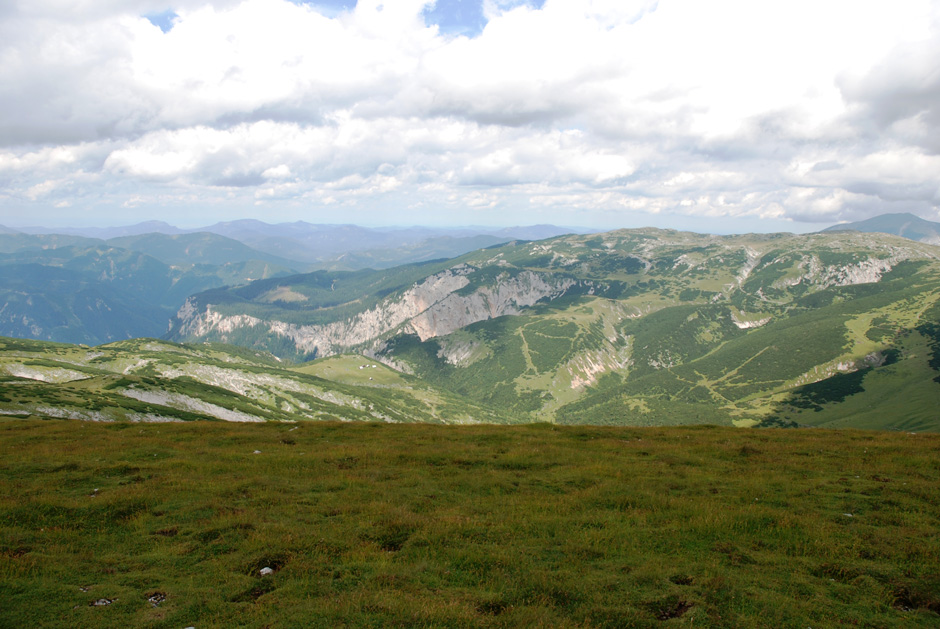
172,229,940,429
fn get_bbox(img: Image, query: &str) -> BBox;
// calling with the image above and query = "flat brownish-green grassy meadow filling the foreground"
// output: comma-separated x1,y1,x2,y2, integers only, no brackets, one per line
0,419,940,629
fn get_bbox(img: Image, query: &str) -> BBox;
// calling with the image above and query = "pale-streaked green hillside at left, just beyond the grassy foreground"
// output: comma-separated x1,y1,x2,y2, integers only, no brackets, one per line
0,338,511,423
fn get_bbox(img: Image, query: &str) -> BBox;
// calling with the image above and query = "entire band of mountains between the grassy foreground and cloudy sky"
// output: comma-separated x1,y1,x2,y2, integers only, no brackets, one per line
0,213,940,431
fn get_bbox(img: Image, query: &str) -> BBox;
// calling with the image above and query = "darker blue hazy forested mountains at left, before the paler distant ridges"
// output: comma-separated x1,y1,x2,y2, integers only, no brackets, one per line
0,240,295,344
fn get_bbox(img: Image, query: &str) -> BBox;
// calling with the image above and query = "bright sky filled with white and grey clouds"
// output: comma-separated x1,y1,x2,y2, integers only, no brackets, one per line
0,0,940,233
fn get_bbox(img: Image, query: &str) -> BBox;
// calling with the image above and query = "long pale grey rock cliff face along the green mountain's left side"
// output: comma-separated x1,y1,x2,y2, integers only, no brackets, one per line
176,265,577,356
